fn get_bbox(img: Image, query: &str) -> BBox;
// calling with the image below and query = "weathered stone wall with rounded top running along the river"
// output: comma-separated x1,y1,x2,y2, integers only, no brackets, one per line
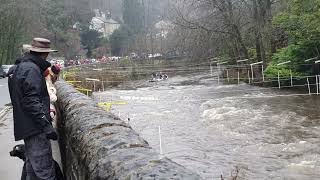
56,81,201,180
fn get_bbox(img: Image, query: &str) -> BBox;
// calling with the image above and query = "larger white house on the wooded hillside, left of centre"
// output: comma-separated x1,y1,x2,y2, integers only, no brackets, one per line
90,9,120,38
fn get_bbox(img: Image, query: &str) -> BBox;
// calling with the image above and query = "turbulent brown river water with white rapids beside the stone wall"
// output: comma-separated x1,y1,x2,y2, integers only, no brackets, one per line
96,75,320,180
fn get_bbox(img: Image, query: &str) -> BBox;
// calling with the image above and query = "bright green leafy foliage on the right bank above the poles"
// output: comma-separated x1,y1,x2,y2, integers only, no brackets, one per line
266,0,320,76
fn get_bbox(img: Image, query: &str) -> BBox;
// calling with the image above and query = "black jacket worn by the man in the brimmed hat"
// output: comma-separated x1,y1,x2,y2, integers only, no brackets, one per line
8,54,52,141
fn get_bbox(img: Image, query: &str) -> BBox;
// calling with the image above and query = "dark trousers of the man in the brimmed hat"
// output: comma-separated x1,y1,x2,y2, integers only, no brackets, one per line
24,134,56,180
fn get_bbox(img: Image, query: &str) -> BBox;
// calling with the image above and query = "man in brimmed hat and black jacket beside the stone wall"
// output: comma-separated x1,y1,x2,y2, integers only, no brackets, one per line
8,38,58,180
